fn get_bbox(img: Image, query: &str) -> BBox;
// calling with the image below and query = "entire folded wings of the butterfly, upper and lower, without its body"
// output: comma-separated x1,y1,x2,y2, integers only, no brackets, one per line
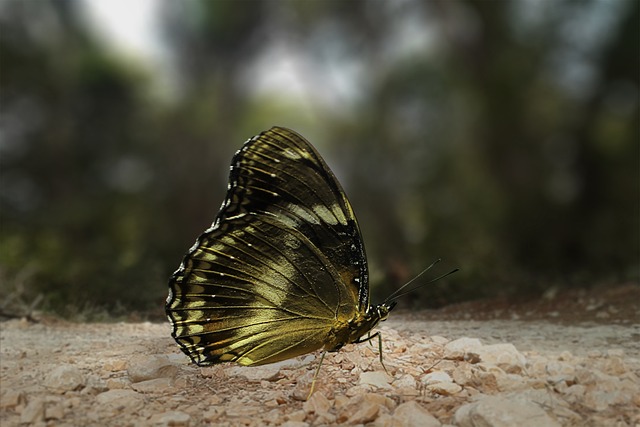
166,127,368,365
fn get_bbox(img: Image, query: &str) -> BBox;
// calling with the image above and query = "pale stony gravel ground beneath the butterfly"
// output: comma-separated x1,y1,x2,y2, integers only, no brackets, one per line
0,284,640,427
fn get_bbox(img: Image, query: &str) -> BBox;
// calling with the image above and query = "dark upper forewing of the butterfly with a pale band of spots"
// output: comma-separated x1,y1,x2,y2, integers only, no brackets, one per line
226,127,369,309
